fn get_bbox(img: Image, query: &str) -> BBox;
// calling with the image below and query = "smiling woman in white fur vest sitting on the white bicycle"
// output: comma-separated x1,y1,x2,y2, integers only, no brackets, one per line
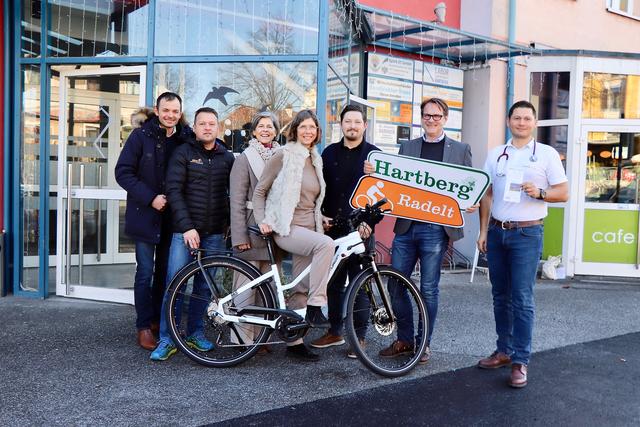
253,110,334,361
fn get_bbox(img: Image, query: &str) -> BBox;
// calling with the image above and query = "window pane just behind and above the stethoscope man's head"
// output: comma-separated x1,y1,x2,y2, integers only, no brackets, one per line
531,71,570,120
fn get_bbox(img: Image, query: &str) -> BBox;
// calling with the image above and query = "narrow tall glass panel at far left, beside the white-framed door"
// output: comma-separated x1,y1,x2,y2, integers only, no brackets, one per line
20,65,41,292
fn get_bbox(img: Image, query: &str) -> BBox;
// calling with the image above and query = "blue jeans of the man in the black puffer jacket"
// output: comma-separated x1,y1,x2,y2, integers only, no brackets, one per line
160,233,225,342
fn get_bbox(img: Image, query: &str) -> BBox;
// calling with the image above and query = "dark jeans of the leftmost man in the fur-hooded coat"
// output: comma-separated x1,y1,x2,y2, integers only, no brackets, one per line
133,233,171,329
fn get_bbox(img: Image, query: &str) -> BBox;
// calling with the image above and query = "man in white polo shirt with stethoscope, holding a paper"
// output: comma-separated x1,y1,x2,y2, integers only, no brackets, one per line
478,101,569,388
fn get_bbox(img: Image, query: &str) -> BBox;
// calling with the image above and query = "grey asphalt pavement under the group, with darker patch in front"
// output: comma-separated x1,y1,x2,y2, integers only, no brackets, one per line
0,274,640,426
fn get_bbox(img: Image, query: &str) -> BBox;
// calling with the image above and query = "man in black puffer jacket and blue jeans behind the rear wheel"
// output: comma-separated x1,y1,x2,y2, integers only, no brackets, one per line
151,107,235,361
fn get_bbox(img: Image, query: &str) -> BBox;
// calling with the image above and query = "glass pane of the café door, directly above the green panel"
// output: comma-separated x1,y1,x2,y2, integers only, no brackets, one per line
585,132,640,203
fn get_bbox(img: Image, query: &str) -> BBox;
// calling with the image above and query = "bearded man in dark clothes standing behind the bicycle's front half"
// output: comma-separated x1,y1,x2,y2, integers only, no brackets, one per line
311,105,379,358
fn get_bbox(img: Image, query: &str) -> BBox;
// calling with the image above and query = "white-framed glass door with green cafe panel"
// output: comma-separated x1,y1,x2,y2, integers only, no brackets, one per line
576,126,640,277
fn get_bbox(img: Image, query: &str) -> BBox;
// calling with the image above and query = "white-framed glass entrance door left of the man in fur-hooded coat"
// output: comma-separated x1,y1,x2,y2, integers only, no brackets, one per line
56,66,145,304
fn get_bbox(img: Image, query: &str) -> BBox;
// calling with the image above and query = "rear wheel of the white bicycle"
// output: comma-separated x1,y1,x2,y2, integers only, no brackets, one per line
165,256,274,367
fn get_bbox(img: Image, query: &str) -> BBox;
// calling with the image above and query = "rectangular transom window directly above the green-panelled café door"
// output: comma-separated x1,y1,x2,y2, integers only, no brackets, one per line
582,73,640,119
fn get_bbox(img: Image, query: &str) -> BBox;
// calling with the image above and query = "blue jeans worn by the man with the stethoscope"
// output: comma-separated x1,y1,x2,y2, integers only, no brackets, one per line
487,224,543,365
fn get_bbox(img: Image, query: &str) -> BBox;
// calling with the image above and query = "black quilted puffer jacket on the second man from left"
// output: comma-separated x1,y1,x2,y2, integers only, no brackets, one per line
167,139,235,235
